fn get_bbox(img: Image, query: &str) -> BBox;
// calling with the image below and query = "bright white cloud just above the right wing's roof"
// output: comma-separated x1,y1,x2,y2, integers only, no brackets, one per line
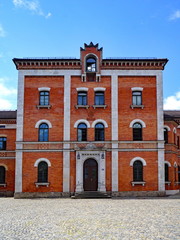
164,92,180,110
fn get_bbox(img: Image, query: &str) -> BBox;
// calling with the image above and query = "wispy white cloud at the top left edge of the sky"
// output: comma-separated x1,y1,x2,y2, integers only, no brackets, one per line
12,0,52,18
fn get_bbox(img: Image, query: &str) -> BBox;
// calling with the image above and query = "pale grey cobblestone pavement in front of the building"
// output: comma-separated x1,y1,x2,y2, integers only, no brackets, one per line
0,198,180,240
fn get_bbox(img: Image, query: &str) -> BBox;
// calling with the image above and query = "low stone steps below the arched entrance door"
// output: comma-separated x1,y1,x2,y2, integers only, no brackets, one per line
71,191,111,199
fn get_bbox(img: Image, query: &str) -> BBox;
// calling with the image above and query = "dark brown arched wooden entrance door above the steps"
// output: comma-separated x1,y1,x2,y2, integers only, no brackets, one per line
83,158,98,191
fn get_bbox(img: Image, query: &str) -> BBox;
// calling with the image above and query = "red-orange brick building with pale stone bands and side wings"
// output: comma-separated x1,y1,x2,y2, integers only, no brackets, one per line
0,43,180,198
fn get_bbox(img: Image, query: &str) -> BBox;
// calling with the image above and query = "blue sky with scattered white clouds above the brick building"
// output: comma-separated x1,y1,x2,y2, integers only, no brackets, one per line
0,0,180,110
